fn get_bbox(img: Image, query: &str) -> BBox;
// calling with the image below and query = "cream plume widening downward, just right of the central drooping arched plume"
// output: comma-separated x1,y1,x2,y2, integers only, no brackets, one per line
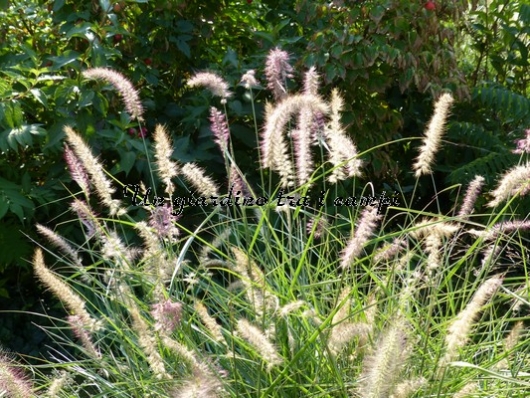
324,89,362,184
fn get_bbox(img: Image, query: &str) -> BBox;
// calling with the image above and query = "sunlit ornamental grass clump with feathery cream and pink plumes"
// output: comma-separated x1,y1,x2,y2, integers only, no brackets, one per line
7,49,529,398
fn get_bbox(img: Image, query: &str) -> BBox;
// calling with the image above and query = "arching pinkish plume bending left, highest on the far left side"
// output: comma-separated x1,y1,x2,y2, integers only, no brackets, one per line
83,68,144,121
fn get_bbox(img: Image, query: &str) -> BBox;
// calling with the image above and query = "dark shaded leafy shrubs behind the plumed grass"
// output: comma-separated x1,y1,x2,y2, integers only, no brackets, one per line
0,0,530,355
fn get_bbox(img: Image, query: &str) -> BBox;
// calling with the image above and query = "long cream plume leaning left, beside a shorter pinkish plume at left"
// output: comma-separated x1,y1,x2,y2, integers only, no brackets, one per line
64,126,125,216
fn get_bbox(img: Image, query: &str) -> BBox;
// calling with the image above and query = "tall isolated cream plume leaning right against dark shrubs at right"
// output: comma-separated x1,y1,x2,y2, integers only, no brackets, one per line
413,93,453,177
